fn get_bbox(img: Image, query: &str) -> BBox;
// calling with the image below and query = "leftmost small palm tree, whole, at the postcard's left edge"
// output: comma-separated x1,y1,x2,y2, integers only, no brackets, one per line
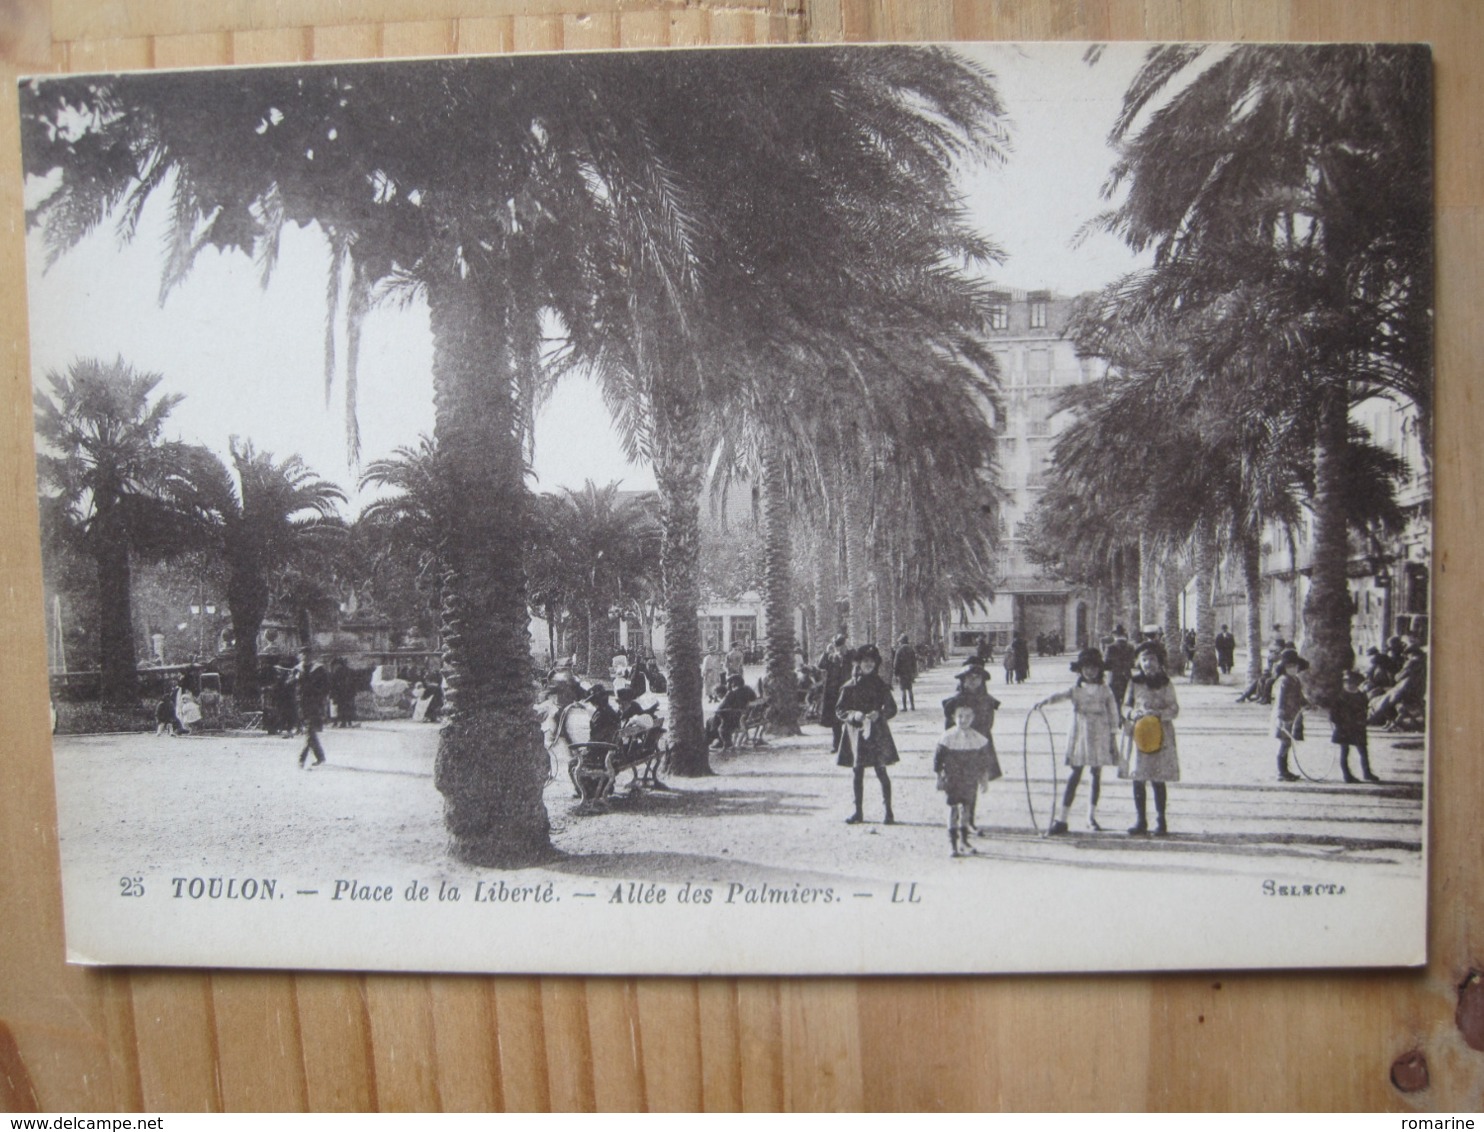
36,358,201,705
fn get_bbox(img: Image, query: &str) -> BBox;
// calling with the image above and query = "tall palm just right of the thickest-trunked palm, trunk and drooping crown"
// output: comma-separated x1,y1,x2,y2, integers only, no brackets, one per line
566,47,1000,774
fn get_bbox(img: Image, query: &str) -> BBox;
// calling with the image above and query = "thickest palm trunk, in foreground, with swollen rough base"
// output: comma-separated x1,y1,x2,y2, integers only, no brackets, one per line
427,276,551,868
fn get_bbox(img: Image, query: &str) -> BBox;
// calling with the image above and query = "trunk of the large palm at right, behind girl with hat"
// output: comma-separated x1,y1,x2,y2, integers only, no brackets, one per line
1303,386,1355,708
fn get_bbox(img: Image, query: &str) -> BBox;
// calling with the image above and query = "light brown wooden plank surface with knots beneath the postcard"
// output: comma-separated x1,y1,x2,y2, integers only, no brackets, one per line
0,0,1484,1111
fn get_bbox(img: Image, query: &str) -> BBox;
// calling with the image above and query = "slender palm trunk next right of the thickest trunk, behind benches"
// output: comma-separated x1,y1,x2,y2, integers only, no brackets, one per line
654,395,711,777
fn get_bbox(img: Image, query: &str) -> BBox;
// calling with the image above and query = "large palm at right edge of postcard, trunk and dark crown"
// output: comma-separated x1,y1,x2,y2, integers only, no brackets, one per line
1103,46,1432,703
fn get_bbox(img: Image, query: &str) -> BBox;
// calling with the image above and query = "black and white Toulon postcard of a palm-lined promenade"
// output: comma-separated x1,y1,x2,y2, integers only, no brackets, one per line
19,43,1447,975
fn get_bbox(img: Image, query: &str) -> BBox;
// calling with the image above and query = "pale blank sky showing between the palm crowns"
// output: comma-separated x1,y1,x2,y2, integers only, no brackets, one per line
27,45,1143,510
